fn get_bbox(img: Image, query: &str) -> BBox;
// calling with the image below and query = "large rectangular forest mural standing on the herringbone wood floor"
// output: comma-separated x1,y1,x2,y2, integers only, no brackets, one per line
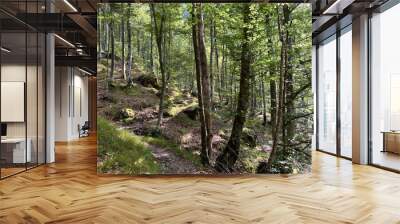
97,3,314,175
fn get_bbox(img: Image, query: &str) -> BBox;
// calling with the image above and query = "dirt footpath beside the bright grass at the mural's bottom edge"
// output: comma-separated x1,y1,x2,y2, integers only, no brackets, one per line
148,145,199,174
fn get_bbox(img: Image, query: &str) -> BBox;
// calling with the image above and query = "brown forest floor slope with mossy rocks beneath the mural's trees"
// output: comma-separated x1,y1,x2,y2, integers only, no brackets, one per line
97,61,270,174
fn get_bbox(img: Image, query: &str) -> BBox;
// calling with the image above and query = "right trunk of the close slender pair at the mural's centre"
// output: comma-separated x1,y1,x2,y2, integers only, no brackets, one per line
197,3,213,161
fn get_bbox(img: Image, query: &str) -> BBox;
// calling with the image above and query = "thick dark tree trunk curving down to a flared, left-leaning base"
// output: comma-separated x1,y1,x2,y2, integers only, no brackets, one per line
215,4,251,172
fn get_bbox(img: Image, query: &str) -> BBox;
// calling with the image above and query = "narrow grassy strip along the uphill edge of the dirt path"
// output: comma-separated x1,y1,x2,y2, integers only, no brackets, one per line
141,136,202,168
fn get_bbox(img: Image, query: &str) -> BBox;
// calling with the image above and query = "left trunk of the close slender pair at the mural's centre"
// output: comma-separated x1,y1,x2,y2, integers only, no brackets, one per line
192,3,209,165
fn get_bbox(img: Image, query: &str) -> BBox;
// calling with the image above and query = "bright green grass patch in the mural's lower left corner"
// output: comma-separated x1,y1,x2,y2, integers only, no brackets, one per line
97,117,160,175
